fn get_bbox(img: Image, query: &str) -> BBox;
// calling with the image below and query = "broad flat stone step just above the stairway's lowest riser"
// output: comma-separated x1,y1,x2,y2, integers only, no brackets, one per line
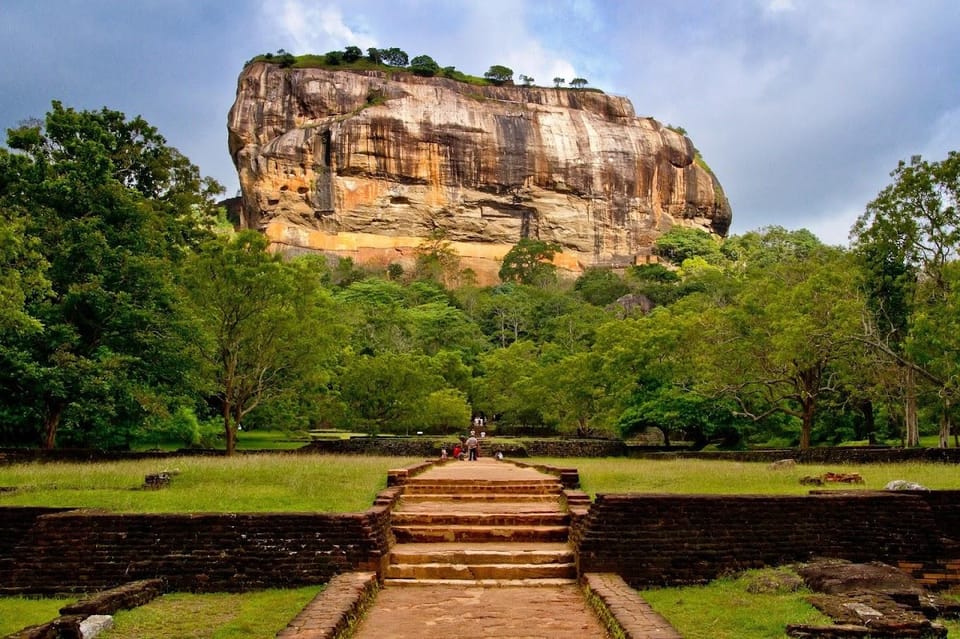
390,543,574,565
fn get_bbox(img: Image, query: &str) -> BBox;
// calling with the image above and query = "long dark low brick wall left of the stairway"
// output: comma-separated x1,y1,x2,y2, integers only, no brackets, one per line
0,500,390,594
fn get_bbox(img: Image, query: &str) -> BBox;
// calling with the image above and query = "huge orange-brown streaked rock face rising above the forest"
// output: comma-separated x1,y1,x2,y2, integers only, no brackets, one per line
228,62,731,283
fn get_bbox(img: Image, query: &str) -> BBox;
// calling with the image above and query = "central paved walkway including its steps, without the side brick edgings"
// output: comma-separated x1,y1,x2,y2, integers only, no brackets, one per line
353,458,607,639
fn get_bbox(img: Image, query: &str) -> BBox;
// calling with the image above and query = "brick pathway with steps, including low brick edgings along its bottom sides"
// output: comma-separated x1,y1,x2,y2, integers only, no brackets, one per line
280,458,680,639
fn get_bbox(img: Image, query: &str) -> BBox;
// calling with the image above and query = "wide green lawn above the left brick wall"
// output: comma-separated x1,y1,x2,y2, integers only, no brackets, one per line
0,454,422,512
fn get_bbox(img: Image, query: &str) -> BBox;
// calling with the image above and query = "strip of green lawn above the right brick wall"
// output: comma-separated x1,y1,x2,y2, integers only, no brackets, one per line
535,458,960,496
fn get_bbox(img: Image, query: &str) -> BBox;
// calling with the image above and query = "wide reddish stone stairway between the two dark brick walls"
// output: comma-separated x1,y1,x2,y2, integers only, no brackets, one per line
384,458,576,586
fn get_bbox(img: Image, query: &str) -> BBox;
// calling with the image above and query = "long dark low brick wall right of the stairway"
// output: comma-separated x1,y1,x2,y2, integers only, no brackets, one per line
571,492,958,586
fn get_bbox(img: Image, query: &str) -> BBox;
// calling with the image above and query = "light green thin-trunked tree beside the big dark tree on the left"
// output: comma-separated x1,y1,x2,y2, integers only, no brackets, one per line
182,231,335,454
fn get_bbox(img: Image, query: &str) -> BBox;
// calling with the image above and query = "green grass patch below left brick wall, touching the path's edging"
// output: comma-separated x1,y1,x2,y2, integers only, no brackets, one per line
100,586,320,639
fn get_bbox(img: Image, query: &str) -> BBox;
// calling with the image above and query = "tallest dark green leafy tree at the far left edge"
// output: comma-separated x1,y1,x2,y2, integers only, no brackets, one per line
0,102,221,448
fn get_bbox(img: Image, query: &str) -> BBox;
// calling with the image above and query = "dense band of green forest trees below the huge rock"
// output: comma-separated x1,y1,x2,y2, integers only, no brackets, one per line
0,102,960,449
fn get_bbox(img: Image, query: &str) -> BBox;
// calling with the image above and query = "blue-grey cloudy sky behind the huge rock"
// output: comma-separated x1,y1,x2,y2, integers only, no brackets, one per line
0,0,960,244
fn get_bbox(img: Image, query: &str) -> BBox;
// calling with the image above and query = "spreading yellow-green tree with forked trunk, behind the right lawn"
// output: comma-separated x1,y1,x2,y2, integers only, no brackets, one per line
702,247,863,448
